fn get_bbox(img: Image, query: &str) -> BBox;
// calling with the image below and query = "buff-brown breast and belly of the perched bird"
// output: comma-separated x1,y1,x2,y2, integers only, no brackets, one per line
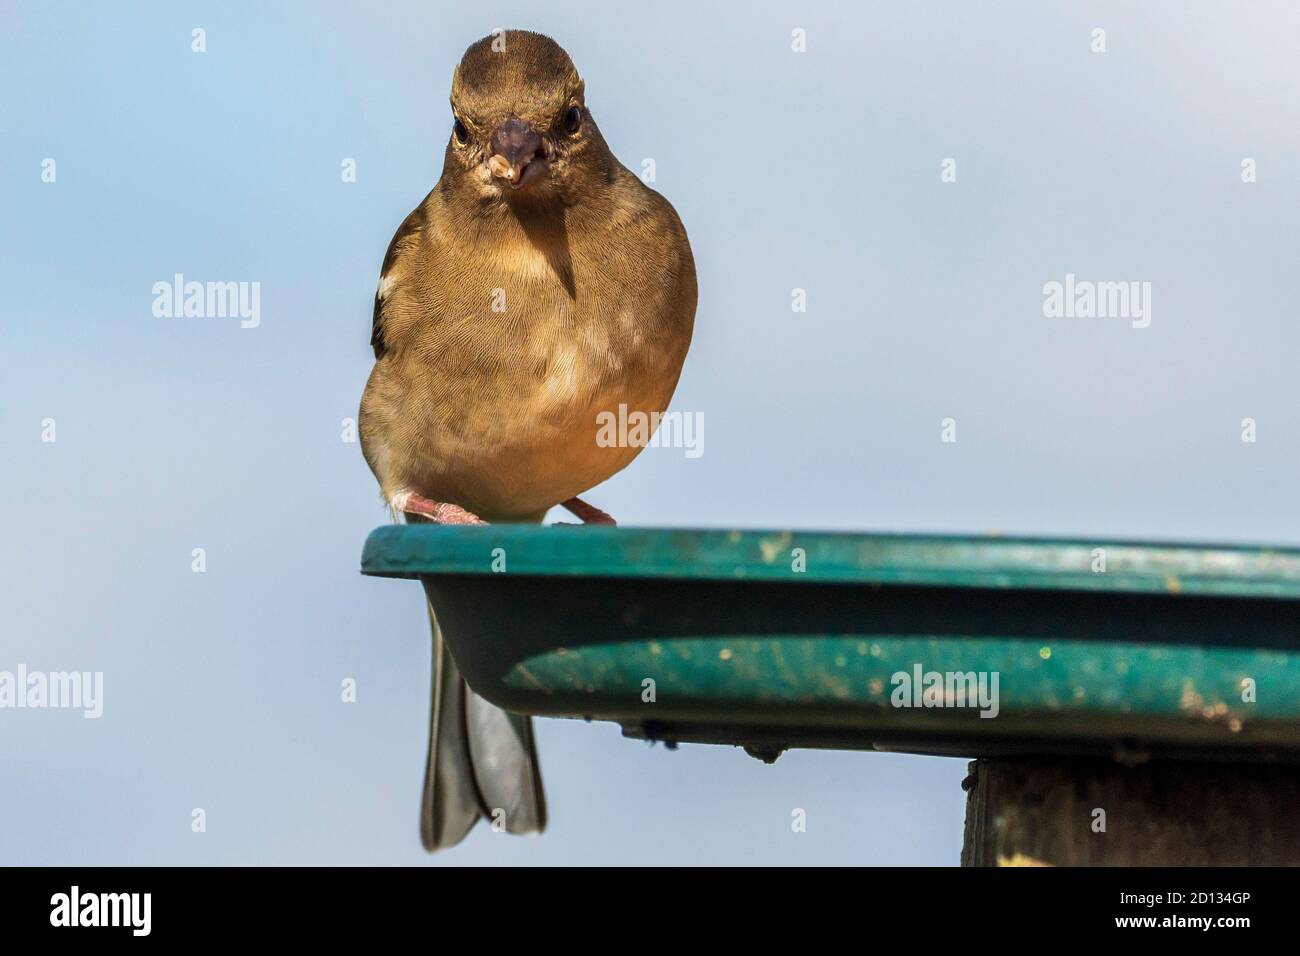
363,195,694,520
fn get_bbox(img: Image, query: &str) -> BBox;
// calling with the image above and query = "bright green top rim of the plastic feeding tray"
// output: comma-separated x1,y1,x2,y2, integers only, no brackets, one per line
361,524,1300,600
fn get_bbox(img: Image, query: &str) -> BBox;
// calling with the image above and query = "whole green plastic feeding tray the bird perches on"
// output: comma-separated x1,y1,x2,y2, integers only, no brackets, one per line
361,524,1300,762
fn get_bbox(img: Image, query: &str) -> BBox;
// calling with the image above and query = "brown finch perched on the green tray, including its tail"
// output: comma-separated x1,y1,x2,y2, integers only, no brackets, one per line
358,30,698,852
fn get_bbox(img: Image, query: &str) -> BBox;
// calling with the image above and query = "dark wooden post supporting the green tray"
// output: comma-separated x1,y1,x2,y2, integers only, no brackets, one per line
962,758,1300,866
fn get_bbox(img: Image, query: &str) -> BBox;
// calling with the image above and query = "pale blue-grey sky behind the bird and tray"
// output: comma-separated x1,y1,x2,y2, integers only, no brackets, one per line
0,0,1300,865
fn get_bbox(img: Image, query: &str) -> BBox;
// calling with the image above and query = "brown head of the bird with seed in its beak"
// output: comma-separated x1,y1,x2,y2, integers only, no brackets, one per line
443,30,612,204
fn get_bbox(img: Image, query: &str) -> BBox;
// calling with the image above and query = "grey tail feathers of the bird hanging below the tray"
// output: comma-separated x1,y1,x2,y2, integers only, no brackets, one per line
420,607,546,852
